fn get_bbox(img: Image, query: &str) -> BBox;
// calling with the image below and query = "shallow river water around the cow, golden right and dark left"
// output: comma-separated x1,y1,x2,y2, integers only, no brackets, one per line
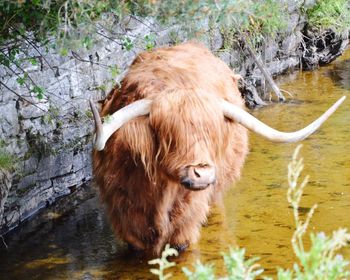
0,51,350,279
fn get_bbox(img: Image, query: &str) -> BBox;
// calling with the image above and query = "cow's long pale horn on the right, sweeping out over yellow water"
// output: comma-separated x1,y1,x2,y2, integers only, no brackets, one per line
222,96,346,142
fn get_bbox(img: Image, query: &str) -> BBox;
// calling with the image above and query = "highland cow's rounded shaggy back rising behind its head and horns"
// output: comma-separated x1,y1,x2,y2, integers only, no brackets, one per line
101,43,243,116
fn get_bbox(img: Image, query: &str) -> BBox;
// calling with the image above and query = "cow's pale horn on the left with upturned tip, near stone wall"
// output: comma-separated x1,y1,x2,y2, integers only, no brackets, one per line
90,99,152,151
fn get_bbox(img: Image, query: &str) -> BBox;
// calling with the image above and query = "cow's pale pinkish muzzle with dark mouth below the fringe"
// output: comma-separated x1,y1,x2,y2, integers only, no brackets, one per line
181,164,216,191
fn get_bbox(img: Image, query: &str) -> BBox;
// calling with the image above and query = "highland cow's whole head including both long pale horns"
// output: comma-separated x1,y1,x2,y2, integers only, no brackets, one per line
90,90,345,190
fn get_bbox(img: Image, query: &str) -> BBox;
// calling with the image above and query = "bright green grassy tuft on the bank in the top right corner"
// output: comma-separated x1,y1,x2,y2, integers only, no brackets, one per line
306,0,350,31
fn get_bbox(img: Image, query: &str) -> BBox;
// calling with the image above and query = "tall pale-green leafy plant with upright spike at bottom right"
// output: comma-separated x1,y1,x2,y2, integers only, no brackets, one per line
278,145,350,280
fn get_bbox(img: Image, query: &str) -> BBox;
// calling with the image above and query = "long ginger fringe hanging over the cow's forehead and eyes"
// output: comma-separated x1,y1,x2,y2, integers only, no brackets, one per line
113,87,226,183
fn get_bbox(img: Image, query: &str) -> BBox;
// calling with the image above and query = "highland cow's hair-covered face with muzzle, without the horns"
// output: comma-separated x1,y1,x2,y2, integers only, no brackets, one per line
149,90,227,190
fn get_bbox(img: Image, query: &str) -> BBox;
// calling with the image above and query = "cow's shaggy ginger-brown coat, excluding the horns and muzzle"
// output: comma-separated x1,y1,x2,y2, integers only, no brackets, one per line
93,43,248,254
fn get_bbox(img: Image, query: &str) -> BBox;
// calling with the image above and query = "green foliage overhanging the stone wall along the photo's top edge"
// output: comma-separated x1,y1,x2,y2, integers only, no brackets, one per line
0,0,290,53
